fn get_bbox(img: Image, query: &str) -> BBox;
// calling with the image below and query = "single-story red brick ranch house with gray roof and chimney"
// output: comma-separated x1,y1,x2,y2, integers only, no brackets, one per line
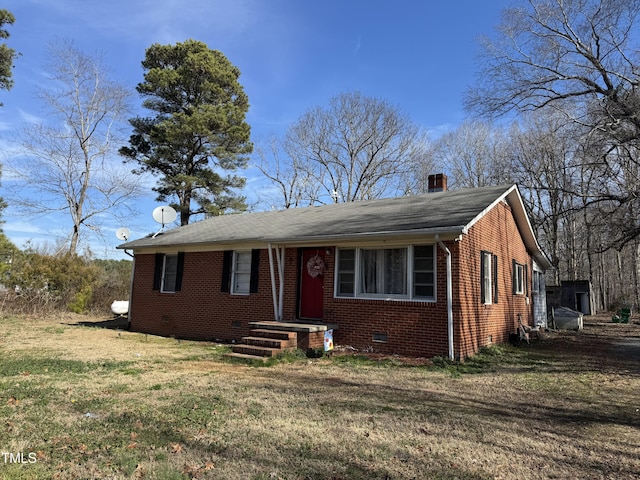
118,175,550,359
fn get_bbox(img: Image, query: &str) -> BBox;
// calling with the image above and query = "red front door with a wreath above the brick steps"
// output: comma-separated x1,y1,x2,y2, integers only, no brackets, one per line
300,248,324,318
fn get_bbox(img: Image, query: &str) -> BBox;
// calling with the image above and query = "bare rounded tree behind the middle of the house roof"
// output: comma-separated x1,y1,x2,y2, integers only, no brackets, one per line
263,92,426,205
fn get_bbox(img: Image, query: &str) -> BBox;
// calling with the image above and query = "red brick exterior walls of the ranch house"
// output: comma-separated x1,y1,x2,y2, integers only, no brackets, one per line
131,203,532,358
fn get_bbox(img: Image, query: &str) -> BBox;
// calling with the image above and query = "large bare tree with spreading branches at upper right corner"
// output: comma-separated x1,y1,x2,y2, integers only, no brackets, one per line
465,0,640,246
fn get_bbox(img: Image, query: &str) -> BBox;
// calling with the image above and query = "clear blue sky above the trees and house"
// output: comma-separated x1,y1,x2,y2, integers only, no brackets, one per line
0,0,510,258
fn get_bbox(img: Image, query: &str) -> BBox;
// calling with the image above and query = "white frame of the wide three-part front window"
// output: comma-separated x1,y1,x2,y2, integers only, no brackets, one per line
333,243,438,303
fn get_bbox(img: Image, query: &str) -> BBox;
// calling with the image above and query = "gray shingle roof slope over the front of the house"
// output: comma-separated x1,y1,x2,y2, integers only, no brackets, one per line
118,185,513,250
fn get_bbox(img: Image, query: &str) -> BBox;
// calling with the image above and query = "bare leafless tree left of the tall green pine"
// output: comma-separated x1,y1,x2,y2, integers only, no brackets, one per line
10,41,139,254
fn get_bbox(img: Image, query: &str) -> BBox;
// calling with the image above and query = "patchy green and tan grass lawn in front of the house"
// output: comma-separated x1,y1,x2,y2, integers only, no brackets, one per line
0,315,640,480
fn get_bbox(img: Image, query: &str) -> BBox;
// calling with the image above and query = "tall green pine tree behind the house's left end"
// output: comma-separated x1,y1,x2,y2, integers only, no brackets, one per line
120,40,253,225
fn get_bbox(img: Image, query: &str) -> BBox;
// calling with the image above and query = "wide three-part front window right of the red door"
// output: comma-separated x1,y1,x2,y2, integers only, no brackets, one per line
336,245,435,301
